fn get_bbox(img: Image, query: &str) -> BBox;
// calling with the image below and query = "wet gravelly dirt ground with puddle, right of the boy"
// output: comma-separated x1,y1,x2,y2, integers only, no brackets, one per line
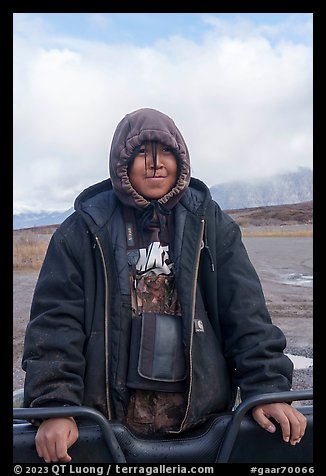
244,237,313,404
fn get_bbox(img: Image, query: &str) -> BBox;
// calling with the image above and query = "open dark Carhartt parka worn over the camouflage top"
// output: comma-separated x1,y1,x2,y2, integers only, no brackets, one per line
23,109,293,431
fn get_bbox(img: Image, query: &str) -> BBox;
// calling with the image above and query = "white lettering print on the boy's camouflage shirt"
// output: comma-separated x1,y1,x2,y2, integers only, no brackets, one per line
136,241,172,275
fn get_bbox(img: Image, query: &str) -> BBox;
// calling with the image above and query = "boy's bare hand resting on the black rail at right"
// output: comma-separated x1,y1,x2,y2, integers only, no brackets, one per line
252,403,307,445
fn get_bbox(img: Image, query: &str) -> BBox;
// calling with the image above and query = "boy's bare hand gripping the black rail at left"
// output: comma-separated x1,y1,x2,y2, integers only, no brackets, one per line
35,417,78,463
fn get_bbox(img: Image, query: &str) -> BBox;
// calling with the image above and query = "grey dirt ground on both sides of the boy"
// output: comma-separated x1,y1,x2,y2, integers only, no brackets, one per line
13,237,313,403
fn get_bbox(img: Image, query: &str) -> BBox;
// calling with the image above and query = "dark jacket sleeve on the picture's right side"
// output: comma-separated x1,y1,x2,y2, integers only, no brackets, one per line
216,214,293,398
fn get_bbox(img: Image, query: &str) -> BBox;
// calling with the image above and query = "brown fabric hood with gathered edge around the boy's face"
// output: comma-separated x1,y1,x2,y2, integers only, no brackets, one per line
109,108,190,209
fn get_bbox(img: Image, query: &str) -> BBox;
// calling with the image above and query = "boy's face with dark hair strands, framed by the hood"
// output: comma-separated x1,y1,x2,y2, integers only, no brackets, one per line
129,142,177,200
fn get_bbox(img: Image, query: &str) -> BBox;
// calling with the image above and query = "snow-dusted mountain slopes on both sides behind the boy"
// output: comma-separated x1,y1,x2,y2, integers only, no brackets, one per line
13,167,313,230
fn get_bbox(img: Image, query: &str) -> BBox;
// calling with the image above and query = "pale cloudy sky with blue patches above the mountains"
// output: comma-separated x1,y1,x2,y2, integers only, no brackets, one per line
13,13,313,213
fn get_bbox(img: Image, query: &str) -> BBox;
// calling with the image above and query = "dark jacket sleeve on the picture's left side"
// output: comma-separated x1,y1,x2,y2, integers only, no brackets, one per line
22,225,85,407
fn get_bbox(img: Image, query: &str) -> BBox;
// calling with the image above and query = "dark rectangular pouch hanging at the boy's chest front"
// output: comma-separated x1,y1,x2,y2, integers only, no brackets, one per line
127,312,186,392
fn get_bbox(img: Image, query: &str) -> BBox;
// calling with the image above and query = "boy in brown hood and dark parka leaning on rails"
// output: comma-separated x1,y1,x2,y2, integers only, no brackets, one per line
23,108,306,462
